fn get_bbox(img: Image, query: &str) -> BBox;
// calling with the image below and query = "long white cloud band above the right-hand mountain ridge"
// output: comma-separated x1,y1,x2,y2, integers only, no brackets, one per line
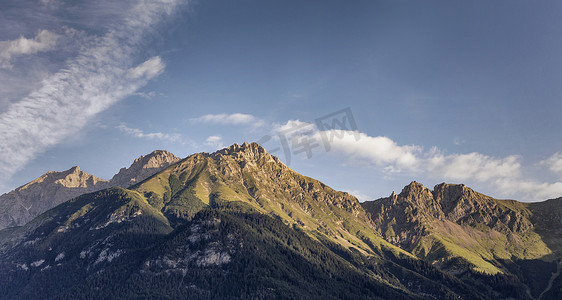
276,120,562,201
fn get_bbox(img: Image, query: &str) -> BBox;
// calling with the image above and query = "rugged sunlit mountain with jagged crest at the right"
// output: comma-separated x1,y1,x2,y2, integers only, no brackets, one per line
362,182,562,297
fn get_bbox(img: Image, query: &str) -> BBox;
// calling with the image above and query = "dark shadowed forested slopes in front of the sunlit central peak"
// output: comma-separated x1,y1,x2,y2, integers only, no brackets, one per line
0,188,491,299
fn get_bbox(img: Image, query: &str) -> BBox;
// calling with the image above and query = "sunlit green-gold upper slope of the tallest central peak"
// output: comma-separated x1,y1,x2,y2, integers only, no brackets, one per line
132,143,409,255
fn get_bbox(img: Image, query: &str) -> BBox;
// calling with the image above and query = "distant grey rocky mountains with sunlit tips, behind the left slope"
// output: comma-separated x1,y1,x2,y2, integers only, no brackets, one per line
0,150,179,229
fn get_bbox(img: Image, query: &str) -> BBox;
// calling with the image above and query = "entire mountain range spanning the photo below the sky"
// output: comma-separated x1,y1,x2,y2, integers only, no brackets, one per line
0,143,562,299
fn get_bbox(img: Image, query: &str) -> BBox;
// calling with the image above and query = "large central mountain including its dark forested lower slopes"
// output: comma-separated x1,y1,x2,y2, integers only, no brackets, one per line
0,143,520,299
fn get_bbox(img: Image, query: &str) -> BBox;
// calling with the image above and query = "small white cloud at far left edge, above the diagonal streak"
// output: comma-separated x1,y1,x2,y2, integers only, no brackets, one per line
0,30,59,69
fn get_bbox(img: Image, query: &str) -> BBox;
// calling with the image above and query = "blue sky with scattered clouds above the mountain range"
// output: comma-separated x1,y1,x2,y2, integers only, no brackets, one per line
0,0,562,201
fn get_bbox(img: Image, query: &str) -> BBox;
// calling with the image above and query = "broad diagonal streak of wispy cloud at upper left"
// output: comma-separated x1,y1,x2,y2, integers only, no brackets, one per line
0,0,181,178
